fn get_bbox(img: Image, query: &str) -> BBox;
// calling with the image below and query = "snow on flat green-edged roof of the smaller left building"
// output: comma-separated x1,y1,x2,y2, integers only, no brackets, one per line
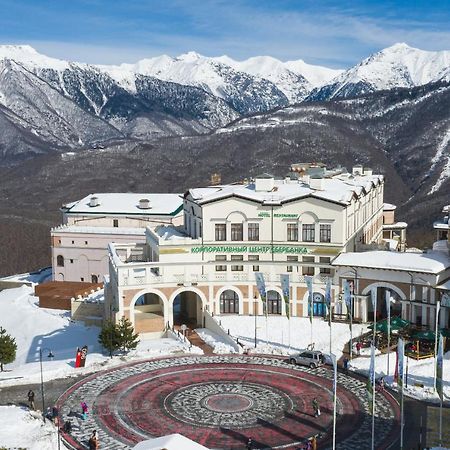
62,193,183,217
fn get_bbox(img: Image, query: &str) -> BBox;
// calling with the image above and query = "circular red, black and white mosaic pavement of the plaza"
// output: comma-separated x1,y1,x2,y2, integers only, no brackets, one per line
58,355,398,450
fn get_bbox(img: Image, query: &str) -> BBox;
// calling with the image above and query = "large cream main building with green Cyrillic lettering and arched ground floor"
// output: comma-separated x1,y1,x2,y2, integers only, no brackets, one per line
105,168,384,335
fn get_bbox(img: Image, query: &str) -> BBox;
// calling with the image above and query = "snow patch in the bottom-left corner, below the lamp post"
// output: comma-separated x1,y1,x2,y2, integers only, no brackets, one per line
0,406,67,450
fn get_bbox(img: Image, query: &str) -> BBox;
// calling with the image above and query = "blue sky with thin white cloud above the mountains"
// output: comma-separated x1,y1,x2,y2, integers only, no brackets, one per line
0,0,450,68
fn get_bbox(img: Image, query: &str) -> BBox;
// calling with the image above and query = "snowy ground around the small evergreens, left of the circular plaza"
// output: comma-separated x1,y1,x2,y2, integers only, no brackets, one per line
0,286,197,386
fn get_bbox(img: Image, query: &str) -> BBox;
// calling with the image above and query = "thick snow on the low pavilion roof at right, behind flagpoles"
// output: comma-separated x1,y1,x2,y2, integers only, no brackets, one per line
331,251,450,273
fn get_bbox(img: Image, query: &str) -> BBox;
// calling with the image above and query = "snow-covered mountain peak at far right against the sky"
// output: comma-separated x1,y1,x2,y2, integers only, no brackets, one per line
308,44,450,100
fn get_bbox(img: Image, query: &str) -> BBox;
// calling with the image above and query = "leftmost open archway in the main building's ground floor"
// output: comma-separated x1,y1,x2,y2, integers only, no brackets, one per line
132,292,165,333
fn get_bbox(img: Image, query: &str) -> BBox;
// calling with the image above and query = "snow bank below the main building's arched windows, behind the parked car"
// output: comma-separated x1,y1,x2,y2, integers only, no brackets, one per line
217,316,367,359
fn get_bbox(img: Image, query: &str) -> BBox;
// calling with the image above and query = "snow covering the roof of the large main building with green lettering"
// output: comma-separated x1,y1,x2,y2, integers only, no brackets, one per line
189,174,383,205
